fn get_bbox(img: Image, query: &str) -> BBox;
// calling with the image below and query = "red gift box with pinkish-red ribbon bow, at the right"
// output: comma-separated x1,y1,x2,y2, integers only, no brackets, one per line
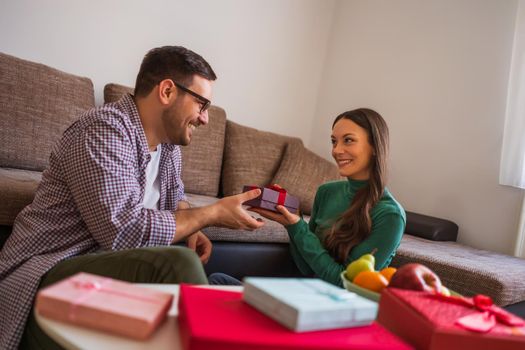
377,288,525,350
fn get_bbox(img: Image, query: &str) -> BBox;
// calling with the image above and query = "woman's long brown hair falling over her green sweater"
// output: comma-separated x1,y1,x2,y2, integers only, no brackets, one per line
324,108,388,264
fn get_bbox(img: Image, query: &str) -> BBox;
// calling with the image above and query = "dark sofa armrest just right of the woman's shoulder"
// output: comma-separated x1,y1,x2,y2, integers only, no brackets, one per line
405,211,458,241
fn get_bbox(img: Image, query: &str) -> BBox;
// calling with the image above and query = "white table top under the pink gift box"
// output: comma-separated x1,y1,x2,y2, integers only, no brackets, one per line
35,284,242,350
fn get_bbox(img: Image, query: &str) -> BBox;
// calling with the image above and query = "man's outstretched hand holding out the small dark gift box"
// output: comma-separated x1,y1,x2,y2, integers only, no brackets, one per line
212,189,264,231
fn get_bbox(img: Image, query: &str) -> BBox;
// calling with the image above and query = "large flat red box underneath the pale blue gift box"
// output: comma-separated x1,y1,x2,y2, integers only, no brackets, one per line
178,285,412,350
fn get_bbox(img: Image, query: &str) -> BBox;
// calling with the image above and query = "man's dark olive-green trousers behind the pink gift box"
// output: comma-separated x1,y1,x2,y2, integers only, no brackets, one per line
20,246,208,349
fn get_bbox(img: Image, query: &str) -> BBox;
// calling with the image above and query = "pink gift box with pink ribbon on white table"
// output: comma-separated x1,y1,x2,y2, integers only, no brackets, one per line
35,273,173,340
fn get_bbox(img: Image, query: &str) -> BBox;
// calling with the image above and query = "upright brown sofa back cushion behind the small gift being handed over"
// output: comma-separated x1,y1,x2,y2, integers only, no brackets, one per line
222,120,302,196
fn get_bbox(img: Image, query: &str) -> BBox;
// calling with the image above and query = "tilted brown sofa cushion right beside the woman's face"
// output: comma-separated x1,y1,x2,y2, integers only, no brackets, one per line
272,142,342,214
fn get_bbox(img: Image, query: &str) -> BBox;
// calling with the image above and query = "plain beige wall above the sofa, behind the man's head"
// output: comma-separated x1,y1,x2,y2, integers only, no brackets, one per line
0,0,335,144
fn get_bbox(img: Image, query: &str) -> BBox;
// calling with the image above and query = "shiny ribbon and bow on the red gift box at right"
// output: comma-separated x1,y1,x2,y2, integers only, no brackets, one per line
432,293,525,333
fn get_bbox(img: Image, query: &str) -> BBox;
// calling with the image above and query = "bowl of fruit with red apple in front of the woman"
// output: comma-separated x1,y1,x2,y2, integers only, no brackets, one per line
341,252,452,301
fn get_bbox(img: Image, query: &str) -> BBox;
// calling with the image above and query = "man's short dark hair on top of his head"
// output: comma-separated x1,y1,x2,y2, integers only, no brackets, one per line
135,46,217,97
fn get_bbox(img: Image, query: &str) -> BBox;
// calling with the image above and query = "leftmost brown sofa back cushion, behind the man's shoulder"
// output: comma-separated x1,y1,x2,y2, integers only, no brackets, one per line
0,53,95,170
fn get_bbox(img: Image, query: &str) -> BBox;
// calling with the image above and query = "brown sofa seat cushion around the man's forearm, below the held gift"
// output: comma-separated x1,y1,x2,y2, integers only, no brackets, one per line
186,193,290,243
